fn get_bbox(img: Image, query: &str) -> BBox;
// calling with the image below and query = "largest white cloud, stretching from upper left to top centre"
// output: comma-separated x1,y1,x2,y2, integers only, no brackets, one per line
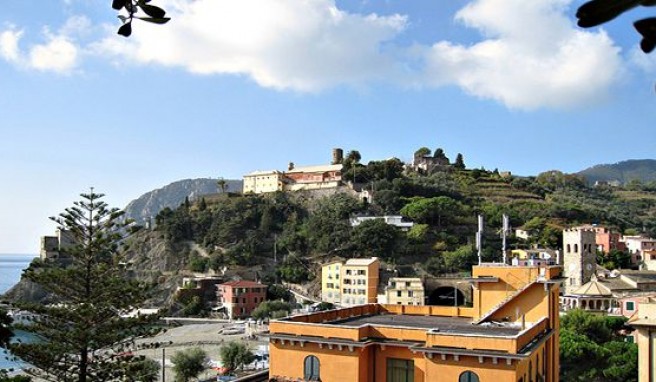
95,0,406,91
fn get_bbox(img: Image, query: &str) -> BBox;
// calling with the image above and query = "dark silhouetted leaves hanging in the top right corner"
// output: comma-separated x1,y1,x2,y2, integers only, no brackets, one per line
576,0,656,53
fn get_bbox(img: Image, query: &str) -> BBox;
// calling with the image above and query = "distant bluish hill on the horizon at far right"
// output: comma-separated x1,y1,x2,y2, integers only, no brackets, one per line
578,159,656,184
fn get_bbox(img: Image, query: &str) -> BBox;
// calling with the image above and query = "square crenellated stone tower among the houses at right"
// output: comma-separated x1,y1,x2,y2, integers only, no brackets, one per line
563,228,597,294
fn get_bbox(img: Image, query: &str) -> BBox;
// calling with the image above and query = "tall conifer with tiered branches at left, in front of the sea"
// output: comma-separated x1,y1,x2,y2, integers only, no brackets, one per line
10,189,157,382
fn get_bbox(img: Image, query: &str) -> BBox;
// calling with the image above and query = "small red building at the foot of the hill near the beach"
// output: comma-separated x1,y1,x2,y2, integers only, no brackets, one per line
217,280,267,318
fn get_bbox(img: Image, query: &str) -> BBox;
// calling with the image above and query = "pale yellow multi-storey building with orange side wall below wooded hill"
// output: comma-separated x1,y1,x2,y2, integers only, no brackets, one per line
321,257,380,306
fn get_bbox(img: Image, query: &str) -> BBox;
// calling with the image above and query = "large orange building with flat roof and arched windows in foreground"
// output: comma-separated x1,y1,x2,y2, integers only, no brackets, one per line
269,264,560,382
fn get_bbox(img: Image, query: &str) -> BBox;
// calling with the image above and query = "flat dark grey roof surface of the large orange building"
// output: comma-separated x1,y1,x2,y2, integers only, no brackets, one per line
326,314,522,336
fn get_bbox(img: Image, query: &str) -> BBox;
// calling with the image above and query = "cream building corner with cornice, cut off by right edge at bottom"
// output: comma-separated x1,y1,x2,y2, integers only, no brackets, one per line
629,302,656,382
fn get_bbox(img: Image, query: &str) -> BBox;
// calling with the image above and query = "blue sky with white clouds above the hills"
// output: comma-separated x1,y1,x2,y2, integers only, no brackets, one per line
0,0,656,253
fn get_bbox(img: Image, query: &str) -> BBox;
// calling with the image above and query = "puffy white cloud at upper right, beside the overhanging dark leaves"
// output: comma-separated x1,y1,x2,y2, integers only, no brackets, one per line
427,0,622,109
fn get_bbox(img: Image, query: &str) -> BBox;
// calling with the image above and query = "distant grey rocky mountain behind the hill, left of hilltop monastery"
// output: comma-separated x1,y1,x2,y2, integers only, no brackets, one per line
125,178,242,224
